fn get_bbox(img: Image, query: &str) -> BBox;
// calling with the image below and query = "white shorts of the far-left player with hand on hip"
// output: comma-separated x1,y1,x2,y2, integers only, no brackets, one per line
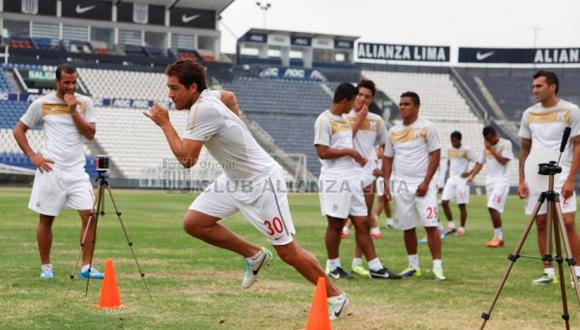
28,168,94,217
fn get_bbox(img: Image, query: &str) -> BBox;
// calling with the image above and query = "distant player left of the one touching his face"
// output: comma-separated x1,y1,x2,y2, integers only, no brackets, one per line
441,131,477,236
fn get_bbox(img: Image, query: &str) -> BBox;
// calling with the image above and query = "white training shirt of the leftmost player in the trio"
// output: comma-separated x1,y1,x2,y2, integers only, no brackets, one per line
314,110,361,179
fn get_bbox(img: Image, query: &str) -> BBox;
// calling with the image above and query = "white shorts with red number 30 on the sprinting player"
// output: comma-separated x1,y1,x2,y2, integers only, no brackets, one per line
189,167,296,245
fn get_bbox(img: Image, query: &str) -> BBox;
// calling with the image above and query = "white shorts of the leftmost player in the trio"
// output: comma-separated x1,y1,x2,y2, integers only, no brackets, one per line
318,178,368,219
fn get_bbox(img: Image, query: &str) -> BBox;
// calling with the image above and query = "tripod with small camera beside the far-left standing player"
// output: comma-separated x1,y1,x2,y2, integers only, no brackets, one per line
65,168,153,301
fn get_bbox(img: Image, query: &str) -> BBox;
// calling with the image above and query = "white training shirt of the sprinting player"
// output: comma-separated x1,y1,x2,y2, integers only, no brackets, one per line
183,89,276,181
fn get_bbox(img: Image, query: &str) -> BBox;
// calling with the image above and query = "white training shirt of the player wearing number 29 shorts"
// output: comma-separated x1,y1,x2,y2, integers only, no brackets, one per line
385,118,441,185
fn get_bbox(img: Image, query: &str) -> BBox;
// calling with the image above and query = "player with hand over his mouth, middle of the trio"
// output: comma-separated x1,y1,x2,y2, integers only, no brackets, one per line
343,79,387,276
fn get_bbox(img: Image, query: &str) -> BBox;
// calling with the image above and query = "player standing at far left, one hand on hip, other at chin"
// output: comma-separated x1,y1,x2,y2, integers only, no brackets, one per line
14,64,103,279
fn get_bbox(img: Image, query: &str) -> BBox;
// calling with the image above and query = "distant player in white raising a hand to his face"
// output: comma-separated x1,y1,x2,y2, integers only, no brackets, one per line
467,126,513,248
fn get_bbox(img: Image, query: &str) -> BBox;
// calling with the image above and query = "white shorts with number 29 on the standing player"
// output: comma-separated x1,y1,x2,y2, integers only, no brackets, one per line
391,181,439,230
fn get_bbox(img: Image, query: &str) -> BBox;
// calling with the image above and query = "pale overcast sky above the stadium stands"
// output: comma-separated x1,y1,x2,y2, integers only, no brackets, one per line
218,0,580,53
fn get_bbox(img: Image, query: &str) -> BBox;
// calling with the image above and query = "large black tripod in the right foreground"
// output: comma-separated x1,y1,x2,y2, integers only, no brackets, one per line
480,127,580,329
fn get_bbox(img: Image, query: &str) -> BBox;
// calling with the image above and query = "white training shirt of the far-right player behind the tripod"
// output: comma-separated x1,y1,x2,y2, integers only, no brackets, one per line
518,100,580,169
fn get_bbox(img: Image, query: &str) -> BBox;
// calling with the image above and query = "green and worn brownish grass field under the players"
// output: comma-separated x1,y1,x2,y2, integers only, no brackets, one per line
0,188,580,330
